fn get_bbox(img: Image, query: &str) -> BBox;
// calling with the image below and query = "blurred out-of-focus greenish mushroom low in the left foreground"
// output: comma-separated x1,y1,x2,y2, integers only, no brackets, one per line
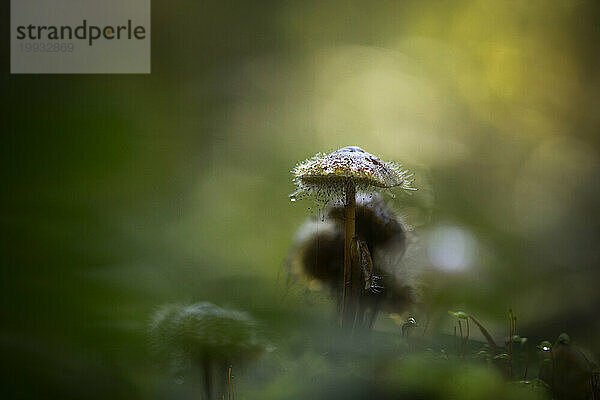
150,302,265,400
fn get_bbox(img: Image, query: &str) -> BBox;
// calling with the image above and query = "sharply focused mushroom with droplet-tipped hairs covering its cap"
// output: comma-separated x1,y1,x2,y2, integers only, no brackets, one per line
291,146,414,327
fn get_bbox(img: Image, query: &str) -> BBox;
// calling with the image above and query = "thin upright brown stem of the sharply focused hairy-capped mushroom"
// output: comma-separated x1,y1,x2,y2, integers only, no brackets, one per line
341,181,356,327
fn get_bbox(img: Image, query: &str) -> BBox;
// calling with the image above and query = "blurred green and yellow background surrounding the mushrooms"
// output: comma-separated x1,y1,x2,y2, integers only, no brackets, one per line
0,1,600,399
